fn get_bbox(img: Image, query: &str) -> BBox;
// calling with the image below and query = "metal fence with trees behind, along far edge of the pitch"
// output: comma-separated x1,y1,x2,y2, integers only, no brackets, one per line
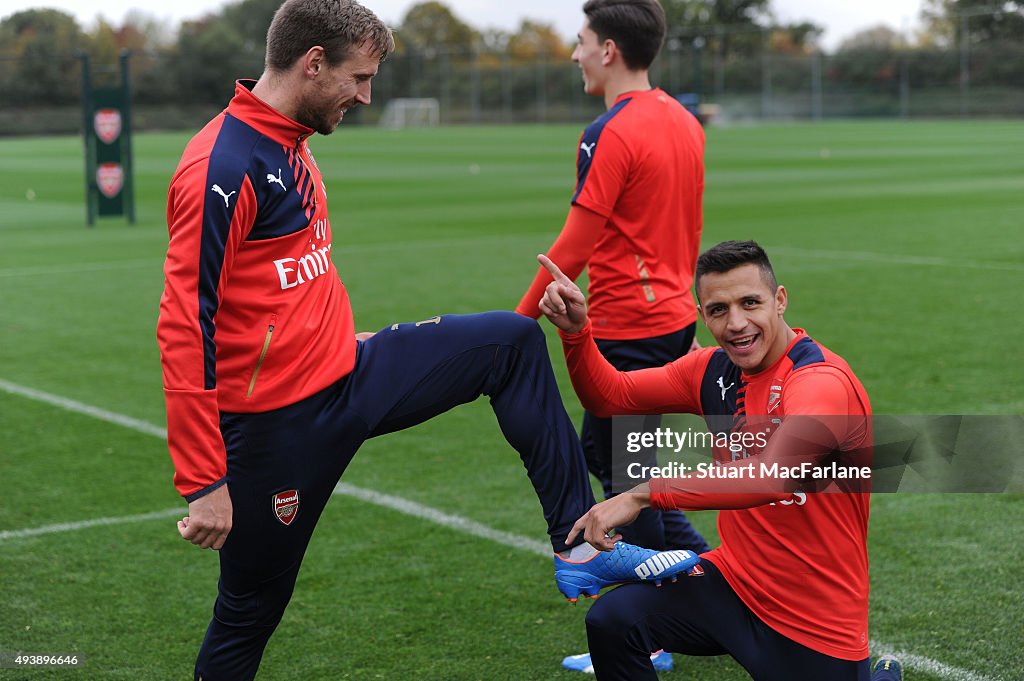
0,38,1024,135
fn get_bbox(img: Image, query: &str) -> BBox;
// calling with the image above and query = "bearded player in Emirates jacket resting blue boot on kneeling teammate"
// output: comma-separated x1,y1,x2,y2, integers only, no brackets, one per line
157,0,697,681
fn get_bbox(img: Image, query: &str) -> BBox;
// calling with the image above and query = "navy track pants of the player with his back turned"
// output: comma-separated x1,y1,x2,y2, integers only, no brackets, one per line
580,324,711,553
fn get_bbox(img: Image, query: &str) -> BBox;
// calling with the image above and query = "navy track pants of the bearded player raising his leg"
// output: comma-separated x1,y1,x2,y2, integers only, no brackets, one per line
196,312,595,681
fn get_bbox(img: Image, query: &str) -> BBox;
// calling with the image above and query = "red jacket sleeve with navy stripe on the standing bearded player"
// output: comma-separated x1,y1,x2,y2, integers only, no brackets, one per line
157,163,256,501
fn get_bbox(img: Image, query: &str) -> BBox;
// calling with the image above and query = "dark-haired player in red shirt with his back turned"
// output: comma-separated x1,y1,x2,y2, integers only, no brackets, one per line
516,0,708,552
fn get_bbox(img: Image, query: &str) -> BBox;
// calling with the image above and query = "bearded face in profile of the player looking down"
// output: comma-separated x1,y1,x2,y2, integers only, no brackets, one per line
296,43,380,135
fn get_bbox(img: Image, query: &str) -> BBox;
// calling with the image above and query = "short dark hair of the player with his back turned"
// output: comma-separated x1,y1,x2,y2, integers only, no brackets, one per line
583,0,666,71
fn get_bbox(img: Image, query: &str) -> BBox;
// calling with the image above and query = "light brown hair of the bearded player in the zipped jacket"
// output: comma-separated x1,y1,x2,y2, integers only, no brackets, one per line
266,0,394,72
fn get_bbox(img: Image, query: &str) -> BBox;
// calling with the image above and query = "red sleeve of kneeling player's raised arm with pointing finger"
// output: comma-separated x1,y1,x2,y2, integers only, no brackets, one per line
559,322,715,418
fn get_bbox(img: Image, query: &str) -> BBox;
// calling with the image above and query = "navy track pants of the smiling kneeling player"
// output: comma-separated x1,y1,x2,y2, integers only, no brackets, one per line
587,560,868,681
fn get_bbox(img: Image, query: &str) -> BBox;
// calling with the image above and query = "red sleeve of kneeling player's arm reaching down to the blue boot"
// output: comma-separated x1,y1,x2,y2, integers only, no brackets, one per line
650,365,868,510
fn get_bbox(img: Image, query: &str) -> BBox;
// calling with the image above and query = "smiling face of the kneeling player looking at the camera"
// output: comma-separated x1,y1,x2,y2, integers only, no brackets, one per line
697,263,794,374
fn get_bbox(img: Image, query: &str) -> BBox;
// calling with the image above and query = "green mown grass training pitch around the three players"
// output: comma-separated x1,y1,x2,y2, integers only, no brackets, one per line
0,121,1024,681
